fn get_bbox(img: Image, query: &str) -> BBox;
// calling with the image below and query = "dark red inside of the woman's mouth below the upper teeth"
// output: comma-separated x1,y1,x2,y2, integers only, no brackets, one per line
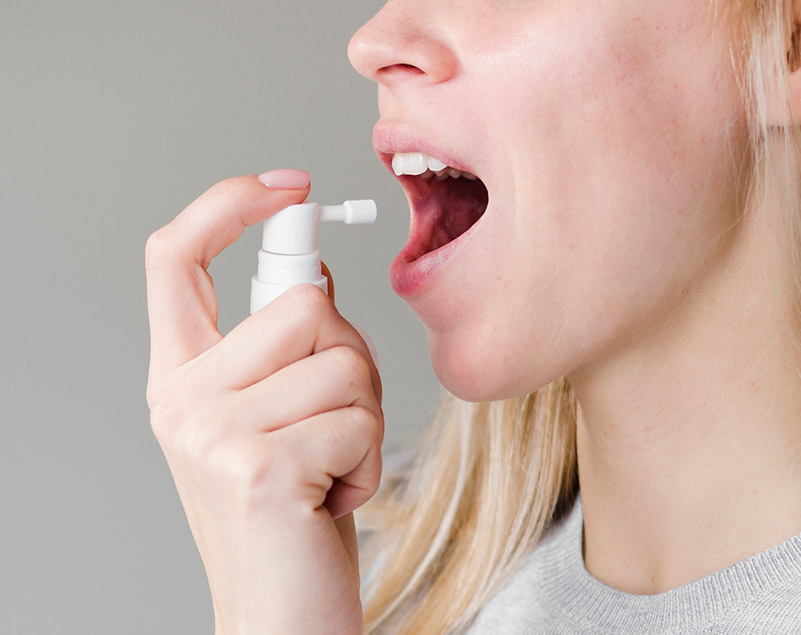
416,178,489,257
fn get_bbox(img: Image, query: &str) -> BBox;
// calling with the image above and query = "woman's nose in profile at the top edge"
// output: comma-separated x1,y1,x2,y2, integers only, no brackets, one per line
348,0,458,86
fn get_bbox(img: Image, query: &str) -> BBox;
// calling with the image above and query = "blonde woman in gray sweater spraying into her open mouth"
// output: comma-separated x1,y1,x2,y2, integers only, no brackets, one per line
147,0,801,633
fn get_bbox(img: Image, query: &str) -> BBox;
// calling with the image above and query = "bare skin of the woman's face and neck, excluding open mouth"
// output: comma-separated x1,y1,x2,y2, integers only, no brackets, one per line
349,0,801,593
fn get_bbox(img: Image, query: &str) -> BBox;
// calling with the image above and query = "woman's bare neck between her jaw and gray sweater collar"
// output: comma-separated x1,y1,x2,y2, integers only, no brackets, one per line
569,214,801,594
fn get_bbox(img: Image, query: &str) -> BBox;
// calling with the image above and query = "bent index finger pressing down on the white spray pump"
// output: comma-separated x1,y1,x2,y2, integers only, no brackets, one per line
145,170,309,376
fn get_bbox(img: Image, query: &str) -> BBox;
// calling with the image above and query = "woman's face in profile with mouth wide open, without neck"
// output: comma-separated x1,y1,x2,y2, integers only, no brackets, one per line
349,0,746,401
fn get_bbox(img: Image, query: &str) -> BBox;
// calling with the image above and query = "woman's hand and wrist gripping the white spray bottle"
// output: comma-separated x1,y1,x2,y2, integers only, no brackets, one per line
146,176,384,635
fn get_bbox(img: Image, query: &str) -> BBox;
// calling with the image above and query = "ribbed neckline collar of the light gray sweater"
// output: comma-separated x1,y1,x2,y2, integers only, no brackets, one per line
537,497,801,633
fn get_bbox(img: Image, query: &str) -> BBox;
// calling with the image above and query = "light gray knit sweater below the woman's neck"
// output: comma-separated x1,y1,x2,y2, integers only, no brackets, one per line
467,498,801,635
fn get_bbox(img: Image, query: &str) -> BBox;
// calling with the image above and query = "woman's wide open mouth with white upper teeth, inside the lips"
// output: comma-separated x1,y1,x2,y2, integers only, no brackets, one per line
392,153,489,262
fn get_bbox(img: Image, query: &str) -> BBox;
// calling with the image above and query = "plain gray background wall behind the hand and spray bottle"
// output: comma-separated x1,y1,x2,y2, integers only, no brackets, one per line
0,0,439,634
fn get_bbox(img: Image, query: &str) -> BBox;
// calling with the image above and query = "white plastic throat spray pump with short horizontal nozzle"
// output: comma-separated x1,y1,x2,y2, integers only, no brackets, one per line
250,200,377,314
